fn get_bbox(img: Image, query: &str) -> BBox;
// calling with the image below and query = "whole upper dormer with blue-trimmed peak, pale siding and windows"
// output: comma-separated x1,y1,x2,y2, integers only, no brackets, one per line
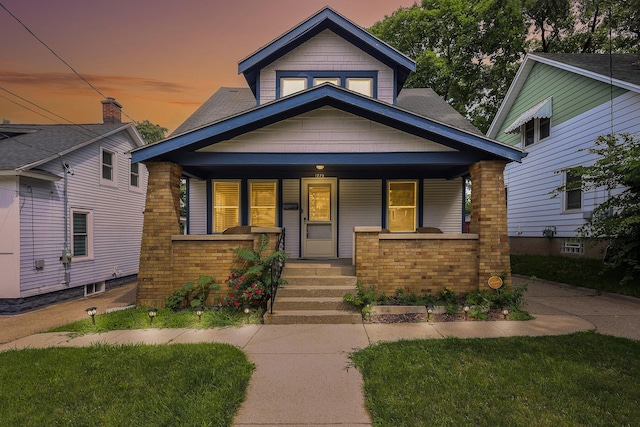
238,8,416,105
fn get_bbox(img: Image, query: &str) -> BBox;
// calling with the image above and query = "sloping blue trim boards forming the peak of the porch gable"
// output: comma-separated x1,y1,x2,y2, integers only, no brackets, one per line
131,84,526,163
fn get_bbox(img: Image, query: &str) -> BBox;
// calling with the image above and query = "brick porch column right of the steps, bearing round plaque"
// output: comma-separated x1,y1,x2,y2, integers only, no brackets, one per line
469,160,511,290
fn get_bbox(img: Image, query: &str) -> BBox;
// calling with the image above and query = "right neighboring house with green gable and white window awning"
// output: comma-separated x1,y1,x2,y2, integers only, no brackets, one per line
487,54,640,256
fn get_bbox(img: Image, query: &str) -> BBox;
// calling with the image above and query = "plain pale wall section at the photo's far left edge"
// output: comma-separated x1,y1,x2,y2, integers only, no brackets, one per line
0,176,21,298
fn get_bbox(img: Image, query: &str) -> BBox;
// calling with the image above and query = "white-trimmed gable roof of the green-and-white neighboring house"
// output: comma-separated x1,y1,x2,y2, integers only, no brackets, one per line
487,53,640,138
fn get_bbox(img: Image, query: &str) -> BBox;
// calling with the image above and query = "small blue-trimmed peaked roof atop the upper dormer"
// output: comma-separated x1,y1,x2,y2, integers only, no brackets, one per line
238,7,416,95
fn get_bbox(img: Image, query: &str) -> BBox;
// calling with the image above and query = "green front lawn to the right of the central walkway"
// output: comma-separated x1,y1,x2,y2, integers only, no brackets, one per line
351,332,640,427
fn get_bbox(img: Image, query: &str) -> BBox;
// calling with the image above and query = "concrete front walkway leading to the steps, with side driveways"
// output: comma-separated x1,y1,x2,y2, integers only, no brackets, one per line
0,278,640,427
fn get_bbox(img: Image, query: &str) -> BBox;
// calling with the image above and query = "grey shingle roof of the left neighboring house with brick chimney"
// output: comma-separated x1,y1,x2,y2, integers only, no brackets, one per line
0,123,130,170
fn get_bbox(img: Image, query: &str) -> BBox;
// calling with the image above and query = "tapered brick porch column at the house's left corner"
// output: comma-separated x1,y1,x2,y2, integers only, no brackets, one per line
136,162,182,307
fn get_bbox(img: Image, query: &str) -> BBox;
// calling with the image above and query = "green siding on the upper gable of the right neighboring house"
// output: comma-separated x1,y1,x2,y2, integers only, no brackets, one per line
496,63,626,144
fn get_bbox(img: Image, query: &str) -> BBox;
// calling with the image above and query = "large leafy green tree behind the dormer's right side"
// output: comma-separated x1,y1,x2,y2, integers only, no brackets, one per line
370,0,526,130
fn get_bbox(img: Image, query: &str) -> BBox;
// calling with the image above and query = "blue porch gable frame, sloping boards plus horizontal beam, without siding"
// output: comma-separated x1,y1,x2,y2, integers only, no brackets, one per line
131,84,525,180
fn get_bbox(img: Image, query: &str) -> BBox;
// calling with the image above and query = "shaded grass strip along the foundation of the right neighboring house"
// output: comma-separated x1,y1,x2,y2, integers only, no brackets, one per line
511,255,640,297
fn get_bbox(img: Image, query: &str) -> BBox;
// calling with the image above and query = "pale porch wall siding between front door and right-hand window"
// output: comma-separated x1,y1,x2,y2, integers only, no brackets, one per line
338,179,382,258
